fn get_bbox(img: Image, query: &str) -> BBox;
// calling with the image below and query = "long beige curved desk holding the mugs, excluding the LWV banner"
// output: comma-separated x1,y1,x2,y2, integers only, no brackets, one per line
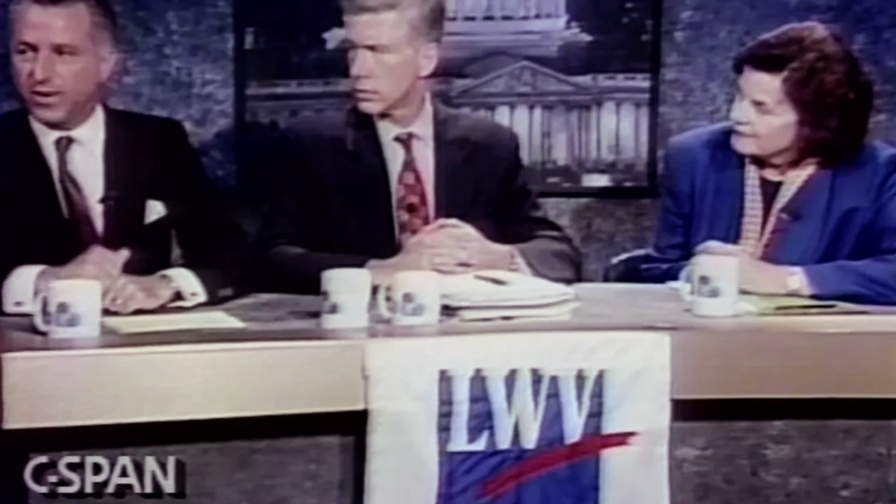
0,284,896,429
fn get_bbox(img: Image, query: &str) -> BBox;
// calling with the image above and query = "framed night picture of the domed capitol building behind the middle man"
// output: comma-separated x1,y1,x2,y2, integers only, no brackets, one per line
243,0,657,192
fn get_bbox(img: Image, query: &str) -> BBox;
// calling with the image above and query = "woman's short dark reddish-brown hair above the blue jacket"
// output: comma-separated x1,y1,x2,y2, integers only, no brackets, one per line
733,22,874,167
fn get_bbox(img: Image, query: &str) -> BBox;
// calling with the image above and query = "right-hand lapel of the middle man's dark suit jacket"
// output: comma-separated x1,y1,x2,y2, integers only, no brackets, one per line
433,102,476,218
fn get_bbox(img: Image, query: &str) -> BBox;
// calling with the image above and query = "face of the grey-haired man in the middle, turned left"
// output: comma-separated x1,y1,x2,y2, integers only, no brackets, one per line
345,11,438,115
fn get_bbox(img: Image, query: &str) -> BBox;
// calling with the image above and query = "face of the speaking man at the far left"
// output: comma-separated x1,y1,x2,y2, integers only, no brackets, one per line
11,2,114,130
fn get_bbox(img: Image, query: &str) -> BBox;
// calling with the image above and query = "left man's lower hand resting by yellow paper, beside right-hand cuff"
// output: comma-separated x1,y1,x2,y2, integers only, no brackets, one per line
103,275,177,314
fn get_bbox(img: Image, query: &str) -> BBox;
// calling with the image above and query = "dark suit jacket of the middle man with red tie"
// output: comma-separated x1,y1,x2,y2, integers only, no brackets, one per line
257,104,580,293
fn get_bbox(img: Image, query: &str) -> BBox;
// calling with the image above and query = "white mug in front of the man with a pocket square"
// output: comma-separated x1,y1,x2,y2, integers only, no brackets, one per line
34,279,103,338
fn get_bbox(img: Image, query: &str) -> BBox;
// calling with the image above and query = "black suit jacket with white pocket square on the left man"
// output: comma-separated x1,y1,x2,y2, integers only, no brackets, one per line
0,108,249,303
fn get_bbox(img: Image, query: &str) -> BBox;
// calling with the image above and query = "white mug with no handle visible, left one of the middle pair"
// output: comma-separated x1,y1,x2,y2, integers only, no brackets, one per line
320,268,373,329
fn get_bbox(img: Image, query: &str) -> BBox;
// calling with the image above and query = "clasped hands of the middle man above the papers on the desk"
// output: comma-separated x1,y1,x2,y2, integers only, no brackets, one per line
406,219,514,274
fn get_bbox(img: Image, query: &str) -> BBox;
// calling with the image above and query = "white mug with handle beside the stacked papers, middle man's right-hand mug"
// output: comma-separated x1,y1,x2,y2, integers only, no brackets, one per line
376,271,442,326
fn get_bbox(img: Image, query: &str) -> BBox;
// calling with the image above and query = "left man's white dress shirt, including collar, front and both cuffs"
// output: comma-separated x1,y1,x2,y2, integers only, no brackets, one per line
3,107,208,314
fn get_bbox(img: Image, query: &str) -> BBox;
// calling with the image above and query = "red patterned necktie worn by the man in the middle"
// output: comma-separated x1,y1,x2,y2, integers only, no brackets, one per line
395,133,429,242
